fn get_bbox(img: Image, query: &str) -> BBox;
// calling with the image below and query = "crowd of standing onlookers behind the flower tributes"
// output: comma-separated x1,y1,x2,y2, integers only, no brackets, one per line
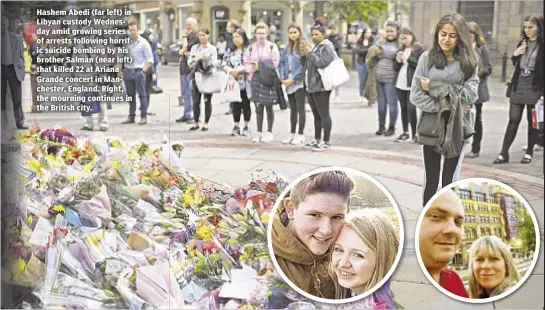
2,9,544,205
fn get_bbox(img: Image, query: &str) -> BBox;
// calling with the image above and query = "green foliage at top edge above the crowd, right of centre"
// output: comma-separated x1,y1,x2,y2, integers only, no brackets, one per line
325,0,388,24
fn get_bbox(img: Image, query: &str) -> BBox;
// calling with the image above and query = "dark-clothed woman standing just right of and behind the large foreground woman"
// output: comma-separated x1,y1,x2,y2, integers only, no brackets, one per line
467,22,492,158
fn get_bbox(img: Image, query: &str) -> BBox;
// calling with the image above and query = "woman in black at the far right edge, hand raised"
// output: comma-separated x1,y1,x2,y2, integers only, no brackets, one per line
494,15,545,164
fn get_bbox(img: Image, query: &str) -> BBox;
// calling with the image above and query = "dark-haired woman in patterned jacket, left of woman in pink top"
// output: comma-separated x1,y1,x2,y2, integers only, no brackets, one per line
221,28,252,136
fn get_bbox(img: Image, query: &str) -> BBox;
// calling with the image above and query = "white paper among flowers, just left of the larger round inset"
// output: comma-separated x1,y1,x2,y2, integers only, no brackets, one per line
219,265,258,300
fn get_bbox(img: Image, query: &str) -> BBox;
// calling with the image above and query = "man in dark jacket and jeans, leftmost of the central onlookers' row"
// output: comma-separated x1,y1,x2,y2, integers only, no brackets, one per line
176,17,199,123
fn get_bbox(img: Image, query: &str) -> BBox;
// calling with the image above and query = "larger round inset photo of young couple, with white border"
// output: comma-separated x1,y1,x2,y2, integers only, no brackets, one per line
267,167,404,308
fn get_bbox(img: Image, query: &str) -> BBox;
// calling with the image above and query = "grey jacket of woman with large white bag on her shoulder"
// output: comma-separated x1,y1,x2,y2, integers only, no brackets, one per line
304,39,337,93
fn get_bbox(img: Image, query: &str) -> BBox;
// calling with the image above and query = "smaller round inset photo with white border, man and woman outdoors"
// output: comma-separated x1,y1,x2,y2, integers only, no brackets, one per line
415,178,540,304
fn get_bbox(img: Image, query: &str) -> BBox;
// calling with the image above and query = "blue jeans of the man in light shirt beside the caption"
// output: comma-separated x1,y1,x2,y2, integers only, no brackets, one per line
123,68,148,118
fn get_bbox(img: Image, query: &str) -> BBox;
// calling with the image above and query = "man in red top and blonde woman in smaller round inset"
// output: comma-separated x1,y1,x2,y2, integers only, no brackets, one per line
419,190,521,299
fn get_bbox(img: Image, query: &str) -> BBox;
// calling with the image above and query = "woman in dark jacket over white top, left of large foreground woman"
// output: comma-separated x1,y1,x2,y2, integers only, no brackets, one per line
394,27,425,142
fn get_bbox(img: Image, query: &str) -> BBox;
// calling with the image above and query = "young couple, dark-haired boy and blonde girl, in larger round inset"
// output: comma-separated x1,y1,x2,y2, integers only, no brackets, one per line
272,171,400,309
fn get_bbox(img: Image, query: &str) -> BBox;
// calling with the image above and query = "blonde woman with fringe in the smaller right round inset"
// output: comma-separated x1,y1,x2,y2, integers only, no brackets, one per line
469,236,520,299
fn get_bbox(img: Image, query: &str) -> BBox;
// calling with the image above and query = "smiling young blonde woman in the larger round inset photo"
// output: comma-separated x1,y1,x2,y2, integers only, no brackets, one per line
331,208,400,309
